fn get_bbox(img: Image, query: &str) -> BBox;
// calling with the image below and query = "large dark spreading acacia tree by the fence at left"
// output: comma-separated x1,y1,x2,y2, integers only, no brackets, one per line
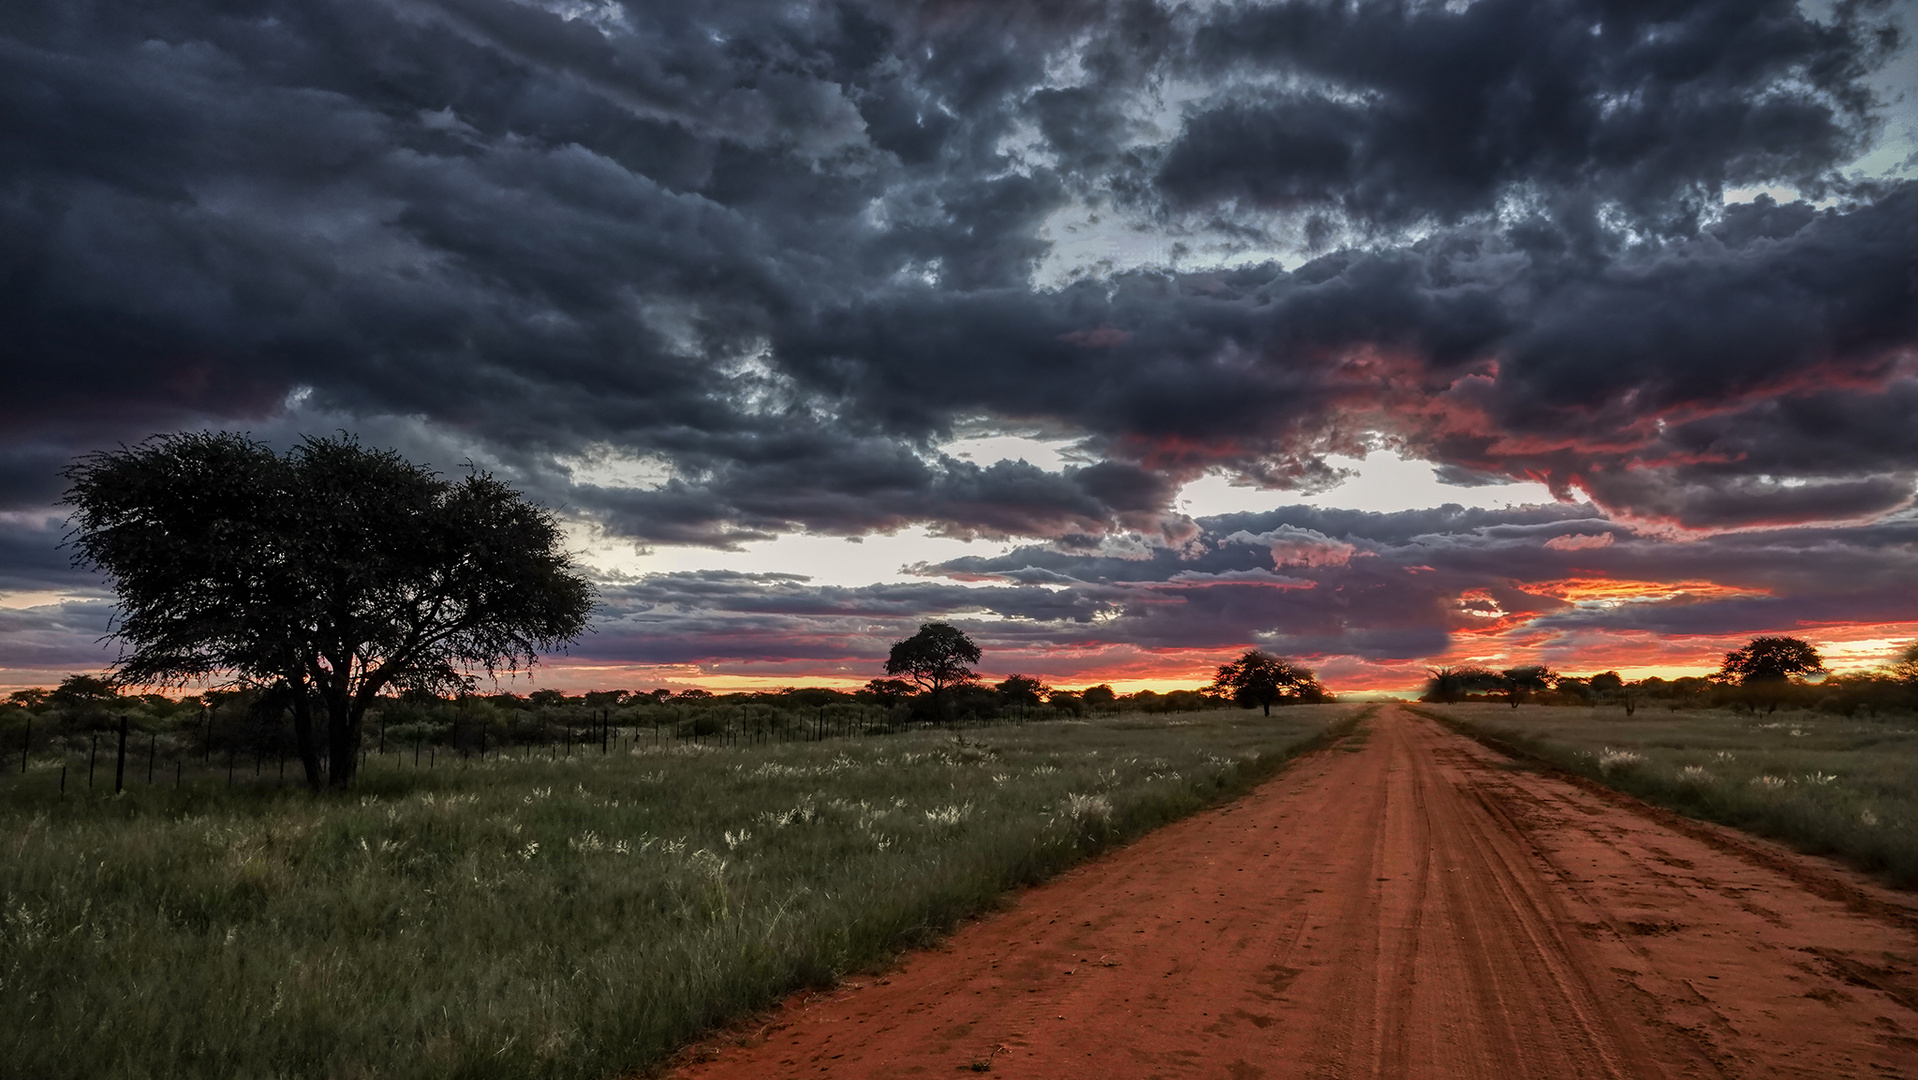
65,434,593,788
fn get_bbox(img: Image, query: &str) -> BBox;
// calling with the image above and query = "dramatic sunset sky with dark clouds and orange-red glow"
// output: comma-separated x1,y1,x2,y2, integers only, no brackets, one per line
0,0,1918,691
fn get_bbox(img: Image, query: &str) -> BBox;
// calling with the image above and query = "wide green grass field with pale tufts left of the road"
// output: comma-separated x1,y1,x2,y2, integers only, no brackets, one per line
0,706,1360,1078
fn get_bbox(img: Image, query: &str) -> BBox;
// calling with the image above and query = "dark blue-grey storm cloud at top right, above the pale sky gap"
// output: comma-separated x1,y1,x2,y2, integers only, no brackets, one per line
1158,0,1895,226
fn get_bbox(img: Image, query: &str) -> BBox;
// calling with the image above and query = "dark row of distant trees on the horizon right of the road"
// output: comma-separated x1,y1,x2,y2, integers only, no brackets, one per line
1421,637,1918,716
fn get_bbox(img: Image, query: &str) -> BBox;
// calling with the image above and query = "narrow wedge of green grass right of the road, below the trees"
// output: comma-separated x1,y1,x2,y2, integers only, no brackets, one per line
1421,704,1918,888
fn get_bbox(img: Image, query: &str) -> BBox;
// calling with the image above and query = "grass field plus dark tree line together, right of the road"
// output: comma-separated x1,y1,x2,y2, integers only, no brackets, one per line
1423,637,1918,888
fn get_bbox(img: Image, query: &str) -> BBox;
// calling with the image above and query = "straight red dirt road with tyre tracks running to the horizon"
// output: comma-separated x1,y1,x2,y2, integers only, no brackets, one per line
681,708,1918,1080
